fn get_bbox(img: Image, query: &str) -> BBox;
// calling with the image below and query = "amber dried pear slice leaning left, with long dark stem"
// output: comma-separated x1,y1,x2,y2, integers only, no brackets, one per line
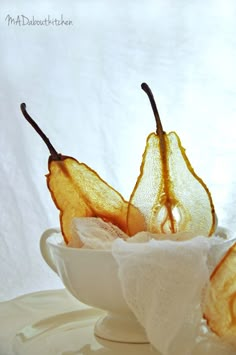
21,104,142,244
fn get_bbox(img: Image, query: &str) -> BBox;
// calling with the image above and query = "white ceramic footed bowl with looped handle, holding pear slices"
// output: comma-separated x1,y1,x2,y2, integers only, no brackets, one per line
40,229,148,343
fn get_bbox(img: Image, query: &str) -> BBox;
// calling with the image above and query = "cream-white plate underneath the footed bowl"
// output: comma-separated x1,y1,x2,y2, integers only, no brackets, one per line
0,290,159,355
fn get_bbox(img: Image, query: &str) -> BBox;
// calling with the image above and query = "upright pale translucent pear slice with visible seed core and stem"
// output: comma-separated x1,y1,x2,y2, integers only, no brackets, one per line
128,83,216,236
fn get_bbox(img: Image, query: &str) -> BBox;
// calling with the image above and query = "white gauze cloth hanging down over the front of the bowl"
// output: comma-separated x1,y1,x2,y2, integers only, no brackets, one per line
112,236,226,355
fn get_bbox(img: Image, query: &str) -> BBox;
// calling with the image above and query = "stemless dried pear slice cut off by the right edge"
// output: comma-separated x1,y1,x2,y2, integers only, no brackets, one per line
203,243,236,344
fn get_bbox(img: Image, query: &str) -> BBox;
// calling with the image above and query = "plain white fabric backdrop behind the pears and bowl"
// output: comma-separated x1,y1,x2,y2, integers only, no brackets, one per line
0,0,236,300
